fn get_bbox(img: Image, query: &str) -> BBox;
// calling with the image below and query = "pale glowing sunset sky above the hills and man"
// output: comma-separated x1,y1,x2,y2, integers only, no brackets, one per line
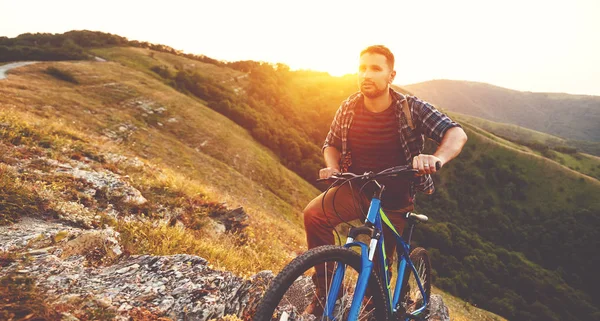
0,0,600,95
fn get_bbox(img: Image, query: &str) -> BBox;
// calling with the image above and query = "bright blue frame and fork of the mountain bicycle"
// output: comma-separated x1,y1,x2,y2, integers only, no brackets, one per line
324,197,429,321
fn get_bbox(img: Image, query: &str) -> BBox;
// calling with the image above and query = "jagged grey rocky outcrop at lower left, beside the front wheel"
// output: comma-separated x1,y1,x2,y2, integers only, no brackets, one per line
0,219,273,321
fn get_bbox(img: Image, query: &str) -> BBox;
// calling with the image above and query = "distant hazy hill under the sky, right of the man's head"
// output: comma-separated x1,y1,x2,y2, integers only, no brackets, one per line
405,80,600,142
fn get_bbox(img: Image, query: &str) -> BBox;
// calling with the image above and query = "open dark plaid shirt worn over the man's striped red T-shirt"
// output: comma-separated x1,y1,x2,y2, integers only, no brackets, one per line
322,89,460,197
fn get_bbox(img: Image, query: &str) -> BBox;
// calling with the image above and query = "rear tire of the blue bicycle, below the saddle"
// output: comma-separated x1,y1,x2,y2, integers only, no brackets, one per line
401,247,432,313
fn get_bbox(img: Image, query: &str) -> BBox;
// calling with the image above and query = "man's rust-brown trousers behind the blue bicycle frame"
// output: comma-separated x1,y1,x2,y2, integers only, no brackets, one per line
304,184,413,274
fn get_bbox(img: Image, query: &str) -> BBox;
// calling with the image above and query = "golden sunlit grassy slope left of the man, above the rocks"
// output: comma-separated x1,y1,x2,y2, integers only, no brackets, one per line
0,58,318,273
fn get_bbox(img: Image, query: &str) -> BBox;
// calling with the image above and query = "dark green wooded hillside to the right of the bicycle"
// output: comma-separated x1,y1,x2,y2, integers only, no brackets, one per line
418,129,600,320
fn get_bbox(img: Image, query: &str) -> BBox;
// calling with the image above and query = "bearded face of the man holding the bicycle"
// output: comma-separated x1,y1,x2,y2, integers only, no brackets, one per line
358,53,396,98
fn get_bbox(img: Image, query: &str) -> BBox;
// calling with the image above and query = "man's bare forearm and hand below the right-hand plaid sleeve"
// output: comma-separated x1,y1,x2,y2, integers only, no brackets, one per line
413,127,467,174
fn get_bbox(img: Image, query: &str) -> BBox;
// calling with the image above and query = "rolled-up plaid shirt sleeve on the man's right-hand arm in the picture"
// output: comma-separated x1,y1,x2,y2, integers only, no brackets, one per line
413,99,462,144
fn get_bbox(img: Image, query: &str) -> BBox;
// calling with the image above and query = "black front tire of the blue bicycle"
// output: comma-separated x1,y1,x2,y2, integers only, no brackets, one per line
253,245,388,321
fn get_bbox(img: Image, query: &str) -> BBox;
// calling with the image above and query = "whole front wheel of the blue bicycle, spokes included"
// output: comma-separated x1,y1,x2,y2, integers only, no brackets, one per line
253,245,388,321
